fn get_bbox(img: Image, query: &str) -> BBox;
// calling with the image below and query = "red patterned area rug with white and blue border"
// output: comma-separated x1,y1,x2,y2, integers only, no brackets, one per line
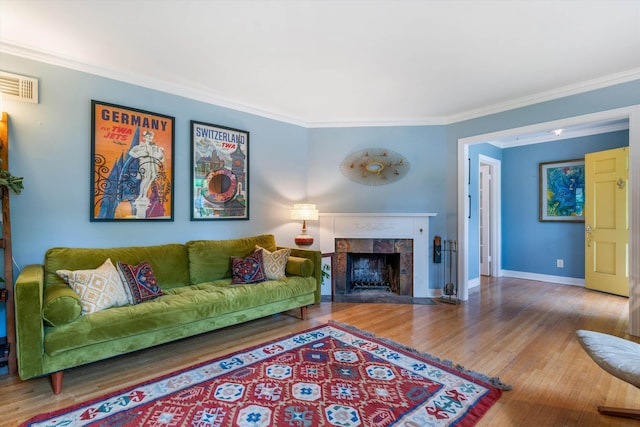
22,323,510,427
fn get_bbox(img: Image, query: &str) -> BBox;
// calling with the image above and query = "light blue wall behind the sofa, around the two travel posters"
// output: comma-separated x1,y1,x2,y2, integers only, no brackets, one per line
0,54,308,336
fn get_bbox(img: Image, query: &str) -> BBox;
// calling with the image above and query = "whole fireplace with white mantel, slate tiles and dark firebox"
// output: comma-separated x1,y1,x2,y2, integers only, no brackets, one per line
319,213,435,298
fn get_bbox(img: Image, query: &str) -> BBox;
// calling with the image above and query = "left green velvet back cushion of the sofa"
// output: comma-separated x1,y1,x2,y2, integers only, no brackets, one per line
44,243,189,289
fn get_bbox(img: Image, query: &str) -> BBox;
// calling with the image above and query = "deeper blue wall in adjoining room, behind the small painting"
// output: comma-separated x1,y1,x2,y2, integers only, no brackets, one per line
502,131,629,279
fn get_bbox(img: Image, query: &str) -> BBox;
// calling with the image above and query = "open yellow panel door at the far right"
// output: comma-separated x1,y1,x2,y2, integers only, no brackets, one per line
584,147,629,297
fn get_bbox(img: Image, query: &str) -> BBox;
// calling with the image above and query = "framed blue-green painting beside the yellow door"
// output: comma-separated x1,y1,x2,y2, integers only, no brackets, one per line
540,159,584,221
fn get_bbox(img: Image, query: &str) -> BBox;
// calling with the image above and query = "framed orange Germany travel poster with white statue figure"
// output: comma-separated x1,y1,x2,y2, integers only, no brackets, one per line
90,100,174,221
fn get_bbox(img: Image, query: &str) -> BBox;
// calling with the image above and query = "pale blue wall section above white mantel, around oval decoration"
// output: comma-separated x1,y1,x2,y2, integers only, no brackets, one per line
308,126,448,288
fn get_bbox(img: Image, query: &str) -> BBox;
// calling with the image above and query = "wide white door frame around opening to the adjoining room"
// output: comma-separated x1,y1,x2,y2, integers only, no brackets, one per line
458,104,640,336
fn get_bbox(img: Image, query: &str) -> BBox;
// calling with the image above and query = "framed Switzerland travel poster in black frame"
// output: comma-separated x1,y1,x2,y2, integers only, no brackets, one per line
191,120,249,221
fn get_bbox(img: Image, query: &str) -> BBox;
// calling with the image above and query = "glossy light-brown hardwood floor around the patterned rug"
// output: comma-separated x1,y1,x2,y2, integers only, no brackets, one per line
0,278,640,426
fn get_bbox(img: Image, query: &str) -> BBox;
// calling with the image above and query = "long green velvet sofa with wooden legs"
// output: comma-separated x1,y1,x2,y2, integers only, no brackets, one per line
15,235,322,394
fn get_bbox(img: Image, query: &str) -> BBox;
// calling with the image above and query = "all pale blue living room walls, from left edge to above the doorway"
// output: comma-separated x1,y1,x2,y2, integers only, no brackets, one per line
0,54,640,336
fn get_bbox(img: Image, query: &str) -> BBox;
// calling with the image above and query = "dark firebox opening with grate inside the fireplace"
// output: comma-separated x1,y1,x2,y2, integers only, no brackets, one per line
346,252,400,295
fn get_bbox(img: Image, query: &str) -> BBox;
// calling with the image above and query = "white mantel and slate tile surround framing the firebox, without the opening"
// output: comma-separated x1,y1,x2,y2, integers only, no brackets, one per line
319,213,435,298
